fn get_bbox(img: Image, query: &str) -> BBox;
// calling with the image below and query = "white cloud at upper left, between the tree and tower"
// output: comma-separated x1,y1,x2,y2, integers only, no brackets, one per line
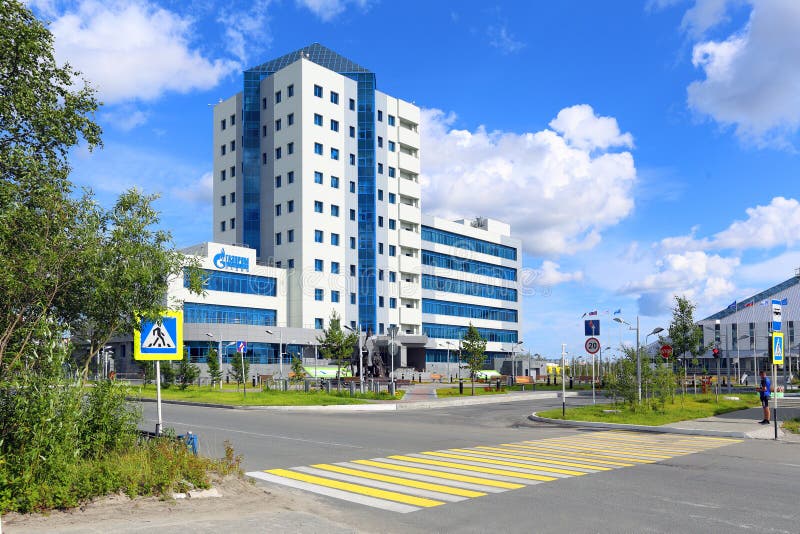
50,0,240,103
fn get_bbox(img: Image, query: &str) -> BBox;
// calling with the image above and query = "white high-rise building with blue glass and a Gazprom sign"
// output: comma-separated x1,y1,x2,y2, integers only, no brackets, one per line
157,44,521,378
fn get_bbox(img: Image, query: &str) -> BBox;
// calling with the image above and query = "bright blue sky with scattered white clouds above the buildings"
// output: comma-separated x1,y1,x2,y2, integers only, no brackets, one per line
27,0,800,357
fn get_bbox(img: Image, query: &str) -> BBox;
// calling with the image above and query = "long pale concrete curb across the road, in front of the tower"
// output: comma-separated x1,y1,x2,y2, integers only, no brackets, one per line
129,391,578,413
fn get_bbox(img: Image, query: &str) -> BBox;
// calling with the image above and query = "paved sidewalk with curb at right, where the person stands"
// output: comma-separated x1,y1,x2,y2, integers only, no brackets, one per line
529,408,800,443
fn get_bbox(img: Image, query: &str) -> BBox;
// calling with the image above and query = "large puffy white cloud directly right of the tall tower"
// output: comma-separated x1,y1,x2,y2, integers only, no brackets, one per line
420,106,636,255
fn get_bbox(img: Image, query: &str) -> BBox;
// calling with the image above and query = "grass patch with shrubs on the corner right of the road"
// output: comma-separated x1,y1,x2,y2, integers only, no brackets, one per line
537,393,759,426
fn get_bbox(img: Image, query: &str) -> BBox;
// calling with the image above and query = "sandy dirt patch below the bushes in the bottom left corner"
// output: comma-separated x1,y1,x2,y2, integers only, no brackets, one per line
0,477,358,534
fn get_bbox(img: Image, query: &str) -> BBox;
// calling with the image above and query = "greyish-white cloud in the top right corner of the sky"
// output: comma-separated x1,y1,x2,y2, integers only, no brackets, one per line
687,0,800,146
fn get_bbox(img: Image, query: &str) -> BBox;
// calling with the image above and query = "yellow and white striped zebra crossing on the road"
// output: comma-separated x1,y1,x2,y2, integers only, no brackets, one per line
247,431,741,513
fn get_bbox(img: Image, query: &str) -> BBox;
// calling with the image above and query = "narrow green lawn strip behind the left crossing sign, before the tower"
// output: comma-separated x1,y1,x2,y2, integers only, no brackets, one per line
130,385,403,406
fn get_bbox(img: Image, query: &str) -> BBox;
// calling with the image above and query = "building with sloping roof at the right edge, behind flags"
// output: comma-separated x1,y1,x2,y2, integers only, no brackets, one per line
697,269,800,383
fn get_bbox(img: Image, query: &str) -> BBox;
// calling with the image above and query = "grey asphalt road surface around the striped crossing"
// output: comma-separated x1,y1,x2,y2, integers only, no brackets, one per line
144,399,800,533
